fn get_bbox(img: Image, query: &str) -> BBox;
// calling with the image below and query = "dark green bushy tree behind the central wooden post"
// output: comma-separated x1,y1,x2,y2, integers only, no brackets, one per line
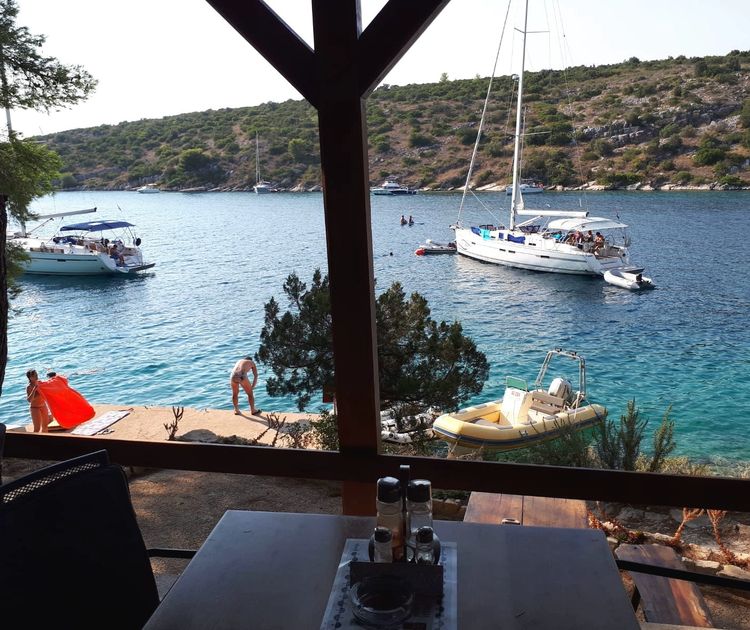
256,269,489,410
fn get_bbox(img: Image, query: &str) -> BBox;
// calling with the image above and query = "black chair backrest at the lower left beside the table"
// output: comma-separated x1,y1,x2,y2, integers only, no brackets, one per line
0,451,159,628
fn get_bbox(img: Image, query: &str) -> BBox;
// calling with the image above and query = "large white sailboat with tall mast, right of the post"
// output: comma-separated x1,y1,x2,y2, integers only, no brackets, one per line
451,0,630,276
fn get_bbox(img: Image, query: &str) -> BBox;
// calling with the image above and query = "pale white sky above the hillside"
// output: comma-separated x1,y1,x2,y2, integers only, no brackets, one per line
12,0,750,137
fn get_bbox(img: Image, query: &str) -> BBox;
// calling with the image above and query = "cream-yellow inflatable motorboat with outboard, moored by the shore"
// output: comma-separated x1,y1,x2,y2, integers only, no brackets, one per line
432,348,607,454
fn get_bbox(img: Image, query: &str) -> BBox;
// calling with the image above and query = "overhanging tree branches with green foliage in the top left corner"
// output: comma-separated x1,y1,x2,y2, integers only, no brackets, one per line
0,0,96,135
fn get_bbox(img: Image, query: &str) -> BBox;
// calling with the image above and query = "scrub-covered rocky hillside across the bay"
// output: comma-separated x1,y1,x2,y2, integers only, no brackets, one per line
37,51,750,190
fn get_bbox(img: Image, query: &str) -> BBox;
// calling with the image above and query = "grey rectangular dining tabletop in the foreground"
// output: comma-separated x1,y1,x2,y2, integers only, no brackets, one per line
145,510,639,630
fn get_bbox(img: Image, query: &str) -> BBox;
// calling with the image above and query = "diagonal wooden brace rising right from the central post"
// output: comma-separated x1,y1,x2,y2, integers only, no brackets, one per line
360,0,450,97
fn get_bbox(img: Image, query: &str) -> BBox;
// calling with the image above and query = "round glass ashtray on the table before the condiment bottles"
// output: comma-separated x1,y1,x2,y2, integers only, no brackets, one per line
349,575,414,628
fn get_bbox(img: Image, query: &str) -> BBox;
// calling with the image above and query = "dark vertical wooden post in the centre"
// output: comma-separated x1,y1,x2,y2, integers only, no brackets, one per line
313,0,380,514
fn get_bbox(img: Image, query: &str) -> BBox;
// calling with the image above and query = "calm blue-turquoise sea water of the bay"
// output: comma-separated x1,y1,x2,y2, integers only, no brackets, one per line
0,192,750,460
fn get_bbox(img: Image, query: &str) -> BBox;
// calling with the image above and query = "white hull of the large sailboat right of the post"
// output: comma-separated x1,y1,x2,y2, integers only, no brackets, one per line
455,228,628,276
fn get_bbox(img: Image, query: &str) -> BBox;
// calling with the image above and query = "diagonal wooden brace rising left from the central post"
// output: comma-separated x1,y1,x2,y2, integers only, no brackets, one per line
206,0,320,107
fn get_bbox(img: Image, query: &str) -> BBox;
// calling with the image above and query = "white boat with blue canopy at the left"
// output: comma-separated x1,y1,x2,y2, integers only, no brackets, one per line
7,208,156,276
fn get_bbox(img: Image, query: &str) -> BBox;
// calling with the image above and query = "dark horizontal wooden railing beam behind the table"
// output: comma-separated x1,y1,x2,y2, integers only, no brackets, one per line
5,431,750,512
